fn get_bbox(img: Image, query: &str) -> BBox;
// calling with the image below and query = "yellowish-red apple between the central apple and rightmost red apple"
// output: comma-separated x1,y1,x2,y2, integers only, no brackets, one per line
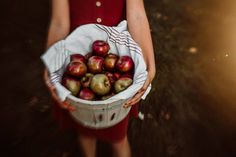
104,53,119,71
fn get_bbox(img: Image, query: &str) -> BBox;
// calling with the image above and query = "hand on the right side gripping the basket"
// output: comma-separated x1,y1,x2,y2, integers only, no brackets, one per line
124,72,155,108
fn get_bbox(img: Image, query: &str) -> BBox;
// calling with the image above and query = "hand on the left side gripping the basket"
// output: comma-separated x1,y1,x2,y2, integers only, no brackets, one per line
44,69,75,111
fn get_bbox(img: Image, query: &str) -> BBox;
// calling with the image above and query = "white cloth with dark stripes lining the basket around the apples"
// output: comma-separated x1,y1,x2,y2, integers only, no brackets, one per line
41,21,151,100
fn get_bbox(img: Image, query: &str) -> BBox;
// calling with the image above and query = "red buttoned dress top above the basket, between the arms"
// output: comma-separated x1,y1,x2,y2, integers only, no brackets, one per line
69,0,126,30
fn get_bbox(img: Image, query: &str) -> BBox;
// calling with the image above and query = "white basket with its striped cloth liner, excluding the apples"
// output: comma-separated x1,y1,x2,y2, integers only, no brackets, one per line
41,21,151,129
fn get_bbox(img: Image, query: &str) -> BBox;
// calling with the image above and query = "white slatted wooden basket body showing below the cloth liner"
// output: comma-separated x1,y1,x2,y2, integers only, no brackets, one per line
67,95,130,128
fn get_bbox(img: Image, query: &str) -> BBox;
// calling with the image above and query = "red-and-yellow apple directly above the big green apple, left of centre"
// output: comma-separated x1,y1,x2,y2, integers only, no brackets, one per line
87,56,104,74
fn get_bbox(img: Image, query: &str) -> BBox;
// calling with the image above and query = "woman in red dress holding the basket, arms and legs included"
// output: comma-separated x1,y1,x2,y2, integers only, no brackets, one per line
44,0,155,157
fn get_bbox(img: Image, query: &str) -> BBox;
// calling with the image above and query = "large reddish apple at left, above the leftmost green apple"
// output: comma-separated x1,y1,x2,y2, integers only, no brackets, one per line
66,61,87,77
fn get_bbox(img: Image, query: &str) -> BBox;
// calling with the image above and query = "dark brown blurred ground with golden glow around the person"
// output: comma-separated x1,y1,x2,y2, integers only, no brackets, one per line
0,0,236,157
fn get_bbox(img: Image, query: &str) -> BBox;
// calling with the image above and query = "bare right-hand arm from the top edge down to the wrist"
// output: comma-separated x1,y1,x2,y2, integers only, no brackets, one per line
127,0,156,75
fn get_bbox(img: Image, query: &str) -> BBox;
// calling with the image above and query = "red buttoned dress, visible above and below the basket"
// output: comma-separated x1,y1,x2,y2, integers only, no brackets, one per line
53,0,138,142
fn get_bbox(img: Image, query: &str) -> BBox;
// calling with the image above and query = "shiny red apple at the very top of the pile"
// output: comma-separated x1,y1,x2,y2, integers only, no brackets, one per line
92,40,110,57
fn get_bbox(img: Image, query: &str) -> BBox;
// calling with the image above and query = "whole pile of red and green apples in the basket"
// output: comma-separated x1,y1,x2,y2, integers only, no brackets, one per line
62,40,134,100
